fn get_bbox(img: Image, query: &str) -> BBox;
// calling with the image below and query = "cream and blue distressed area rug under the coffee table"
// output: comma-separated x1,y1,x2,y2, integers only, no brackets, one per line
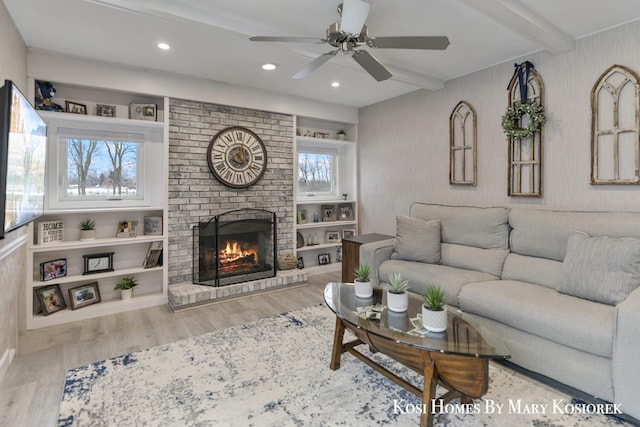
58,305,630,427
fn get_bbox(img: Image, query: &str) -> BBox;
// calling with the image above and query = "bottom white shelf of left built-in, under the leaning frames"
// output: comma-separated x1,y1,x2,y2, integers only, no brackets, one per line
27,290,168,329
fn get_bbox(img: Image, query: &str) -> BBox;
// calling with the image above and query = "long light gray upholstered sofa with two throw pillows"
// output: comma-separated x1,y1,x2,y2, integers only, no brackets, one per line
360,203,640,419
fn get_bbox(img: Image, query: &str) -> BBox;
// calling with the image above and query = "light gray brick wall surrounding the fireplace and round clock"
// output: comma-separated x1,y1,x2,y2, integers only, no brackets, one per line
167,98,294,284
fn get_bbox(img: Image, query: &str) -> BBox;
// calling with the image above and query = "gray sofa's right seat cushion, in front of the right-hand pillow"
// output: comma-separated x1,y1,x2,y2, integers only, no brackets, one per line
458,280,616,358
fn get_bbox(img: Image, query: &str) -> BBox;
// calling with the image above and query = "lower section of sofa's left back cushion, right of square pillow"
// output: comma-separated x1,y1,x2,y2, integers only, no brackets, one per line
441,243,509,277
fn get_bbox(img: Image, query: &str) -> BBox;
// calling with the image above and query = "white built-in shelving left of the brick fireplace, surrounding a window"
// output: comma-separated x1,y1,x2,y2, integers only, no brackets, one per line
25,79,168,329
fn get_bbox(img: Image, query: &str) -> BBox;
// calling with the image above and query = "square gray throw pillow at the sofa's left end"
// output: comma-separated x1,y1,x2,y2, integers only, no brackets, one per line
391,216,441,264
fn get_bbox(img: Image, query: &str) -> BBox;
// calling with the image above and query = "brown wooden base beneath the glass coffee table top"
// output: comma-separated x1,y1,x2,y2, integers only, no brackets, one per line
329,317,489,427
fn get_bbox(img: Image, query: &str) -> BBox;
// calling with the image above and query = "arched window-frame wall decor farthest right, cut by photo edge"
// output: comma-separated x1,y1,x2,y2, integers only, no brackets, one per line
591,65,640,185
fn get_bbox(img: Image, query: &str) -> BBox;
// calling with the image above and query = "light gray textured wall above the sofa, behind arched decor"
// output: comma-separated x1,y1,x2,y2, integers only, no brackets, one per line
358,22,640,234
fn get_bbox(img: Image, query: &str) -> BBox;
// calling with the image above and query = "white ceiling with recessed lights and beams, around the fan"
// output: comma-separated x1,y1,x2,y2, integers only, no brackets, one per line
4,0,640,107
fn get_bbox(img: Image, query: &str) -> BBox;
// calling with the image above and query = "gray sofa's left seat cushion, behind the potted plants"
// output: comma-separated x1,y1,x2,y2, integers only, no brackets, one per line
378,259,497,307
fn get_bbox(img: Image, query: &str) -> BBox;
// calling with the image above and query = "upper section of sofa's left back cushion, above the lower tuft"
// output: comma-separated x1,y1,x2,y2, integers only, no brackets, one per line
410,203,509,249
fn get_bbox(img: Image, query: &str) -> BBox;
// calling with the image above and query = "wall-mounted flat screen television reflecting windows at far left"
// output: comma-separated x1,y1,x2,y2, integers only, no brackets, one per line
0,80,47,239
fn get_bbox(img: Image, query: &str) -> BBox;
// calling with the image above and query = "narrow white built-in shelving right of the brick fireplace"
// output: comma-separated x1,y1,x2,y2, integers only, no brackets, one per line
295,117,358,269
